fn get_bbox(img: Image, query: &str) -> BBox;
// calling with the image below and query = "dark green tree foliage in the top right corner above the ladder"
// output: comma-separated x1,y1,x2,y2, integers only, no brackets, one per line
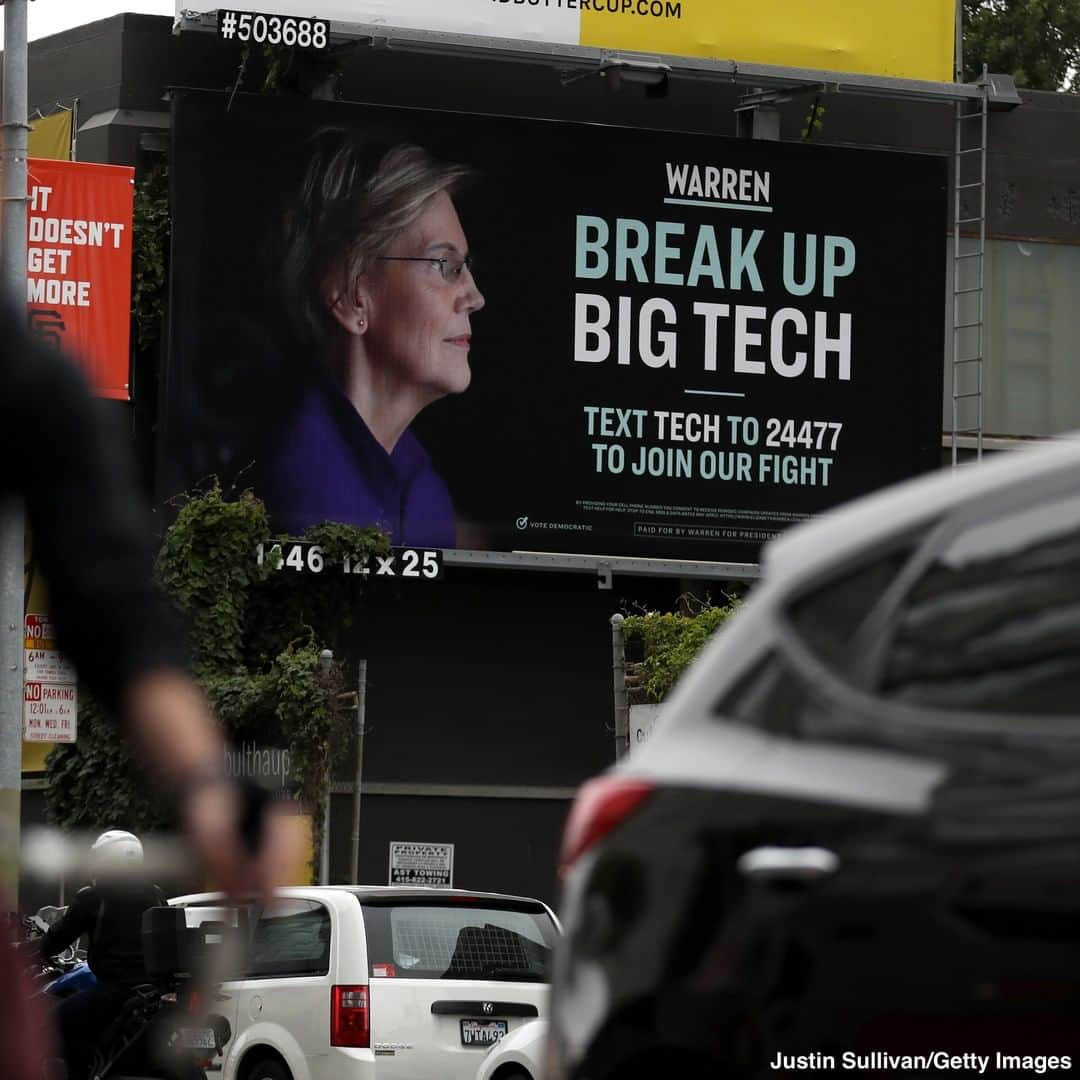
963,0,1080,93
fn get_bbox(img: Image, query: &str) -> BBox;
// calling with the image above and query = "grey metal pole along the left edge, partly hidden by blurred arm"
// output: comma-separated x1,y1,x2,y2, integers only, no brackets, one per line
0,0,29,904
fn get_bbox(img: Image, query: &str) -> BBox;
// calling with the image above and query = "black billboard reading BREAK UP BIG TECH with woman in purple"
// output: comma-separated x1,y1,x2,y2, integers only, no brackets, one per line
159,92,946,561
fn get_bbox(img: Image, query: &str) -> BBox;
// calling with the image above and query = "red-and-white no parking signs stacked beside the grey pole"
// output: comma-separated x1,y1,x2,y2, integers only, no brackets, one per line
23,613,79,742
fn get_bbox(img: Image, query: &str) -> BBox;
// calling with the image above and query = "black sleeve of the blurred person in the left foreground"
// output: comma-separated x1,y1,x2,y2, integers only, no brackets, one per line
0,306,186,707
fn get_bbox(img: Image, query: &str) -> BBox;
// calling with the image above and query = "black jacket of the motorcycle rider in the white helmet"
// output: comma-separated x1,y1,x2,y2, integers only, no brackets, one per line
41,882,165,983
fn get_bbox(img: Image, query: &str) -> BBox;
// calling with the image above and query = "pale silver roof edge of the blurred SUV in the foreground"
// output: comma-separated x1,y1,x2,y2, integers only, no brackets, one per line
762,433,1080,588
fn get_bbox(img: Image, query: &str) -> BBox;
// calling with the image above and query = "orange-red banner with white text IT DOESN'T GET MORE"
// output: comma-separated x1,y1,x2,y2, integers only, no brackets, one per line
26,158,135,401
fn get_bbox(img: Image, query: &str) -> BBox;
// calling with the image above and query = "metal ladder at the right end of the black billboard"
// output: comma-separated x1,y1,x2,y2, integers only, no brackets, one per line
951,71,989,465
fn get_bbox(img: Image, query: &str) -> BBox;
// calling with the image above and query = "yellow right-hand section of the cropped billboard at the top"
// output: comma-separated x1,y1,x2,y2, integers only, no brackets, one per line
581,0,956,82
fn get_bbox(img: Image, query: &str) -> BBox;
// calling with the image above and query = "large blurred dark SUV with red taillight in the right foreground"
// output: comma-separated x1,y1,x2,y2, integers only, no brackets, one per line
548,442,1080,1080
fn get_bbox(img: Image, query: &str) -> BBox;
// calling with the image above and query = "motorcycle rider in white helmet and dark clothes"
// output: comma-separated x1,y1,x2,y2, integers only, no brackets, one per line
40,828,165,1080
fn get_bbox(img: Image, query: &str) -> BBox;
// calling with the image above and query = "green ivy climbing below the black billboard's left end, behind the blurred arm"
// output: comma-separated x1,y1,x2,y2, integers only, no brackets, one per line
46,483,389,847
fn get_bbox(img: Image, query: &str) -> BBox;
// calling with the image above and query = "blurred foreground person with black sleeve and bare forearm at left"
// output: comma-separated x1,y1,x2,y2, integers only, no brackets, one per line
0,306,300,1080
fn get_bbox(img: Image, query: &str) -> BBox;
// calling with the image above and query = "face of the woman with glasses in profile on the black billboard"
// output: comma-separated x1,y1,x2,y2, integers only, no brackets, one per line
364,191,484,400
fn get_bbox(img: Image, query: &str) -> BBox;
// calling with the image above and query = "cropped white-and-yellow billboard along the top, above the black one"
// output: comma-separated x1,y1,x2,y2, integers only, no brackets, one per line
192,0,957,82
